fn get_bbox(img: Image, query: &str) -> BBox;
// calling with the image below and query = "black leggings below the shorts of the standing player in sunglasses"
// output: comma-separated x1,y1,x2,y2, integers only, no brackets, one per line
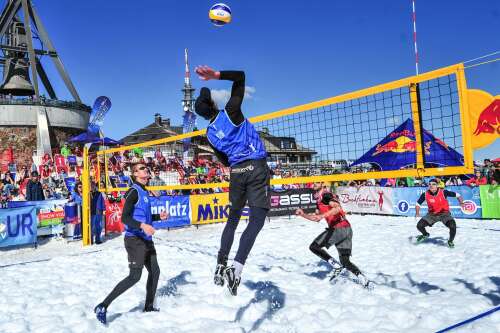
102,250,160,308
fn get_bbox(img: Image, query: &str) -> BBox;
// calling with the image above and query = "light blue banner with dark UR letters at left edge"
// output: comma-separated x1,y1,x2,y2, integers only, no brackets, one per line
0,206,37,247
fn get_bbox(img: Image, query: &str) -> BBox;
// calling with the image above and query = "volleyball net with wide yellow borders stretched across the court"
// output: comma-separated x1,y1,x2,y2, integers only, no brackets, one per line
94,64,473,192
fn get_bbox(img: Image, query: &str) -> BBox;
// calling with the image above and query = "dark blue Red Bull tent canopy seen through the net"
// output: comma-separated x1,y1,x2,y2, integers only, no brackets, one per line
351,119,463,171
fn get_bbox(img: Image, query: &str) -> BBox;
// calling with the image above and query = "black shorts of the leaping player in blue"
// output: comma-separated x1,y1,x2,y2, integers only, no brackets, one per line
229,159,271,209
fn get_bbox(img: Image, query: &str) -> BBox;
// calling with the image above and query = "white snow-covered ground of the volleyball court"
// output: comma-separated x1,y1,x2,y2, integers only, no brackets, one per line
0,215,500,333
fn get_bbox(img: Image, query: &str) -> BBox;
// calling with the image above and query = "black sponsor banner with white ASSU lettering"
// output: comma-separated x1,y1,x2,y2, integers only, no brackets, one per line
268,188,316,216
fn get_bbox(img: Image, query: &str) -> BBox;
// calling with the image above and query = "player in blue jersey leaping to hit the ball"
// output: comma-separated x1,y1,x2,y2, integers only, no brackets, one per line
195,66,270,295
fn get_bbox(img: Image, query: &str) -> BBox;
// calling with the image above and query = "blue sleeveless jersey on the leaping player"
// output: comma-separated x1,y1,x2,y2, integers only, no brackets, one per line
207,110,267,166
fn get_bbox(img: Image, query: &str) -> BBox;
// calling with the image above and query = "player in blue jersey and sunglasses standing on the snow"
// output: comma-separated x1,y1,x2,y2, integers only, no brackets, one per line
94,163,168,324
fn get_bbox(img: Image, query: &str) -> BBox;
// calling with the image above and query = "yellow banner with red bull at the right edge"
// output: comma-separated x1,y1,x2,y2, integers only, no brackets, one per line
468,89,500,149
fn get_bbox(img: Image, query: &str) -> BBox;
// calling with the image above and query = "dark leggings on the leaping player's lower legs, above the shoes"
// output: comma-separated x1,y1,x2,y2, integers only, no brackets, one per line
217,207,269,265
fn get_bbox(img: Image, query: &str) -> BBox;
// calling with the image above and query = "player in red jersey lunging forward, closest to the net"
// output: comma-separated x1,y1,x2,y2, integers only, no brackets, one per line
296,192,370,287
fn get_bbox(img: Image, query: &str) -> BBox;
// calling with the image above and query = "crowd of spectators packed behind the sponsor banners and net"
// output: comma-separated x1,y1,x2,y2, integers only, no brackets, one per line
0,140,500,207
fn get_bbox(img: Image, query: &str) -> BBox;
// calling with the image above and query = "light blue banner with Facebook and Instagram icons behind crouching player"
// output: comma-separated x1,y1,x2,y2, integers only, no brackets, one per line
393,186,482,218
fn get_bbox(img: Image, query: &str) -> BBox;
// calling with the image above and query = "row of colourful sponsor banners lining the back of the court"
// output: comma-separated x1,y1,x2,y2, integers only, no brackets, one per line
0,185,500,247
